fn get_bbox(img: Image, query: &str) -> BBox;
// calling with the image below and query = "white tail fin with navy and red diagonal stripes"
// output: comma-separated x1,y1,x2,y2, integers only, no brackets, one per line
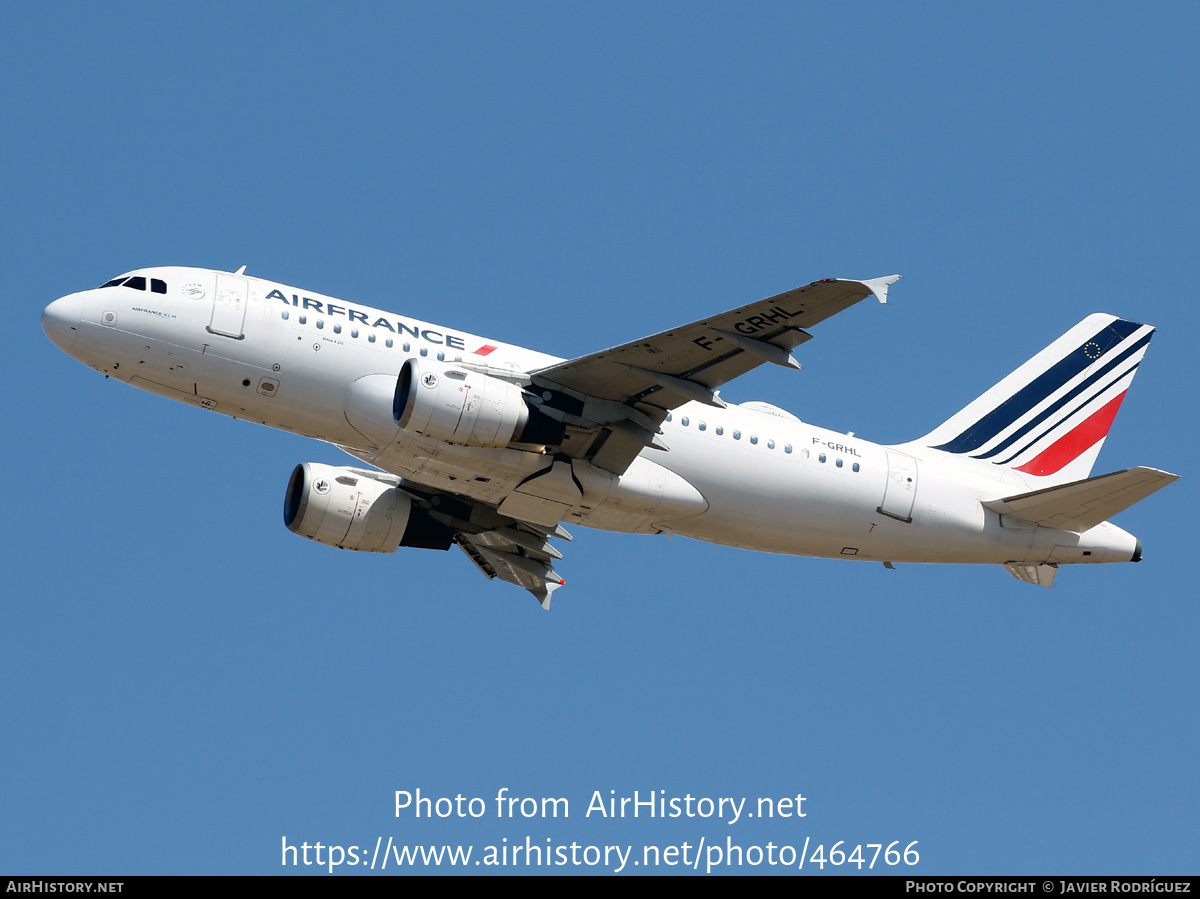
917,312,1154,486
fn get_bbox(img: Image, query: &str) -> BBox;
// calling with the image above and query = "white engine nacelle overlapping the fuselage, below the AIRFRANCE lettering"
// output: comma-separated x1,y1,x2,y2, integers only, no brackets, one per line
392,359,535,446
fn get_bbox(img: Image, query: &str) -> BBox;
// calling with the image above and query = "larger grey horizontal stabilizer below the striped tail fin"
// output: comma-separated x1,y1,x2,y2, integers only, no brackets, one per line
984,467,1180,532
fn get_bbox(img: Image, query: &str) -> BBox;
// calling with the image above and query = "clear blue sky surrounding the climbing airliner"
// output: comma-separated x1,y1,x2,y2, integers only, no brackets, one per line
0,2,1200,876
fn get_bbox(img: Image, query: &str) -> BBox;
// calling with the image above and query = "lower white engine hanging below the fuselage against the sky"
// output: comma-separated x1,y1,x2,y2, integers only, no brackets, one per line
283,462,454,552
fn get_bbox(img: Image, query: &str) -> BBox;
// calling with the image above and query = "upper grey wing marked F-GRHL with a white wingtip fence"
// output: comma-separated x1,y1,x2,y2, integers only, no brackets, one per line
530,275,900,474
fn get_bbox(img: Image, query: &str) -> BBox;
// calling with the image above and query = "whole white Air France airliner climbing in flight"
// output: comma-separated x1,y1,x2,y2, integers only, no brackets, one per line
42,266,1177,609
